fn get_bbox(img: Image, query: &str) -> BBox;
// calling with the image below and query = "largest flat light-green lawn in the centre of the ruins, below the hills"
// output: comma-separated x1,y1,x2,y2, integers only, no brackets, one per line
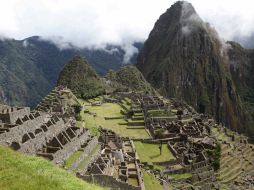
81,103,150,139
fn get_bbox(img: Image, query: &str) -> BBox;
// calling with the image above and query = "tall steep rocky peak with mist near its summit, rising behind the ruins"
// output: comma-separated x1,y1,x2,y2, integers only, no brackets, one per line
136,1,245,131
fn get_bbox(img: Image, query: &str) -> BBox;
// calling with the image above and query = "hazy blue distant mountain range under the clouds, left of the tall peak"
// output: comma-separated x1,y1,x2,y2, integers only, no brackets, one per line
0,36,142,107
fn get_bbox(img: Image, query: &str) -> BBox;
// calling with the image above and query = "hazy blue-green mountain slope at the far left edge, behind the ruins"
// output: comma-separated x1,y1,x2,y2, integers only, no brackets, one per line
0,40,50,105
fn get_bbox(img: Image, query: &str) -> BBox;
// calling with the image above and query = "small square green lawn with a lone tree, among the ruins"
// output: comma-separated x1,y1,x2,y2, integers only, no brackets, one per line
134,141,175,163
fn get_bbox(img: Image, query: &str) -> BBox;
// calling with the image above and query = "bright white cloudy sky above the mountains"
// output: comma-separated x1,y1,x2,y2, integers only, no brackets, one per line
0,0,254,47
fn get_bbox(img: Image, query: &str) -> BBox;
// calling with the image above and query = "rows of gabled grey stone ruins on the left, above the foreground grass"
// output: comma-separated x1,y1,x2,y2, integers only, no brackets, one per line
0,87,94,165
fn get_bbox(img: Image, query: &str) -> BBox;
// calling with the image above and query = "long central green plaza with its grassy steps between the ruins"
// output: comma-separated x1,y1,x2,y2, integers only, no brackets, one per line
80,97,150,139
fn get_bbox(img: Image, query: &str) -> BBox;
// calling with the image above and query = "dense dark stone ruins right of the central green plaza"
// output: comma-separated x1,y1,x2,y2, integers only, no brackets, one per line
113,93,216,189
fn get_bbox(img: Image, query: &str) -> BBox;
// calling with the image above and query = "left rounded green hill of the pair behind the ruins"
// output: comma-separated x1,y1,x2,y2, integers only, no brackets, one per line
57,56,105,98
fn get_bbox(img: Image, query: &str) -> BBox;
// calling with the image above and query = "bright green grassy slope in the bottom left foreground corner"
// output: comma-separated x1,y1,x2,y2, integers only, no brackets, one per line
0,146,103,190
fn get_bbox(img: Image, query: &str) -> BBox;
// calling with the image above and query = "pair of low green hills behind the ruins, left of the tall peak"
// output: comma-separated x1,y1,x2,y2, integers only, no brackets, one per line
57,56,156,99
